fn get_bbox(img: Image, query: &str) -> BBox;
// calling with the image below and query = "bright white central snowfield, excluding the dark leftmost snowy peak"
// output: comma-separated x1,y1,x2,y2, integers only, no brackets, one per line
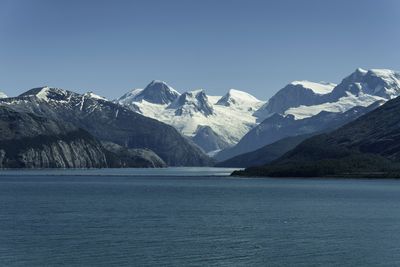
118,89,265,145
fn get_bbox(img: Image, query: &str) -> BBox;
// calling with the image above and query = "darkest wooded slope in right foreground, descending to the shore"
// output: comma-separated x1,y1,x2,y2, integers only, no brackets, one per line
236,95,400,177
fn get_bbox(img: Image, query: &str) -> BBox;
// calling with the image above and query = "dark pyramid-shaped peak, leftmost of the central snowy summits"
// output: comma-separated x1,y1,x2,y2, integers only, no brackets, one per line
130,80,180,105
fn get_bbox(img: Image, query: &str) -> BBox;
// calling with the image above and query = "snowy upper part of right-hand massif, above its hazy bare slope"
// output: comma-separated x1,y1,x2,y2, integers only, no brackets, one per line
255,68,400,121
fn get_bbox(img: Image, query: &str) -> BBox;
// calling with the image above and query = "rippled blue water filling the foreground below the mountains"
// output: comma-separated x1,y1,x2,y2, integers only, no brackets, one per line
0,168,400,266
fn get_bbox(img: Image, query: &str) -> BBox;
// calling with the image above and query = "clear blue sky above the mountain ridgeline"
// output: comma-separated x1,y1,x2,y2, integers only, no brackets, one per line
0,0,400,99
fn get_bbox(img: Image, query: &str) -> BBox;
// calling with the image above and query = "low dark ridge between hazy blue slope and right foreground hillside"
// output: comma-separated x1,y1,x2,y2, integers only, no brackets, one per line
215,133,316,168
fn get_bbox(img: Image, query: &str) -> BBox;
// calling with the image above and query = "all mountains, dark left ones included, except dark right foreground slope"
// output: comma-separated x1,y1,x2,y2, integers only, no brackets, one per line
0,69,400,171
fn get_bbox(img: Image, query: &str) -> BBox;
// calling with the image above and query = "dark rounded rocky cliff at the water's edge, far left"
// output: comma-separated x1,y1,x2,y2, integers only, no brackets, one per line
0,106,109,168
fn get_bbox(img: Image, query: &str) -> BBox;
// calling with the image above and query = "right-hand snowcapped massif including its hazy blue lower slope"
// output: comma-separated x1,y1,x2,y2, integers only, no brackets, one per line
216,69,400,160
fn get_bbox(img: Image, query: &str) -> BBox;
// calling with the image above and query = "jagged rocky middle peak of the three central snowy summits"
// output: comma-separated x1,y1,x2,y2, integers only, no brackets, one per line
168,89,214,116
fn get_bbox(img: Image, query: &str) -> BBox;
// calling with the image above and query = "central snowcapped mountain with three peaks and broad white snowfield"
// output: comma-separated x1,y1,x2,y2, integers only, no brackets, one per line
115,82,265,152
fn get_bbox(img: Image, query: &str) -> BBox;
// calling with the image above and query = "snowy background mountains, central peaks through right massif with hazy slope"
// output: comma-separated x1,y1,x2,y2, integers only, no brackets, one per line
114,68,400,161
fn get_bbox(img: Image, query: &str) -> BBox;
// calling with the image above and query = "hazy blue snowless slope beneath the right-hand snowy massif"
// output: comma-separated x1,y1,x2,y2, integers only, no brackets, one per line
215,102,382,161
